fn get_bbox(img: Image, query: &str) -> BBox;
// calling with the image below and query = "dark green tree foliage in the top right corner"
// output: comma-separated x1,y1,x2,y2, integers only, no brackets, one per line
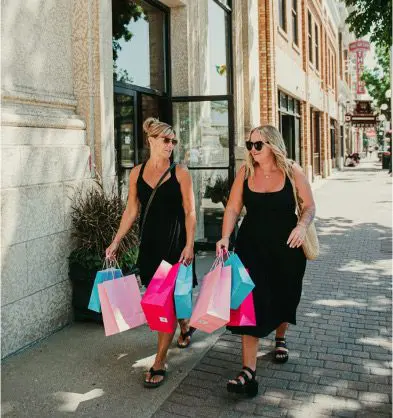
345,0,392,48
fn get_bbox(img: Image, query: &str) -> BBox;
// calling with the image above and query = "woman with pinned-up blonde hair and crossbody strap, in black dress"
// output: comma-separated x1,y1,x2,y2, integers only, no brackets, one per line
106,118,196,387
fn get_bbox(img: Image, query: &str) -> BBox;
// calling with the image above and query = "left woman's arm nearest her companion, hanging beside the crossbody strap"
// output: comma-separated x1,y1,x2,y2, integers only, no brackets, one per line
176,166,196,262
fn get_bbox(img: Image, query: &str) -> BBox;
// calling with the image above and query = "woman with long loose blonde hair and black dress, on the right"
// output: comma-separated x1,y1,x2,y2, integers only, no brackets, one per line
217,125,315,396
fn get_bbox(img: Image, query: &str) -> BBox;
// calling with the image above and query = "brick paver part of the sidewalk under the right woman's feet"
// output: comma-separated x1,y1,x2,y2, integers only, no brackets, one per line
154,161,391,418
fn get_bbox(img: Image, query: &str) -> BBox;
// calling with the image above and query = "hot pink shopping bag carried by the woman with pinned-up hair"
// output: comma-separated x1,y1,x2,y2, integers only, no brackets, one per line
141,260,180,333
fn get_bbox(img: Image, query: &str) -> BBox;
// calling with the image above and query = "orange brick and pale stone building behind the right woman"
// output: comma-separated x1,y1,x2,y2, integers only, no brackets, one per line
259,0,353,181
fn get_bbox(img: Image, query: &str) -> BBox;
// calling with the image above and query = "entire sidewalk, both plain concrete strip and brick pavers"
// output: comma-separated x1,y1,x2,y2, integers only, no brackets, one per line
2,160,392,418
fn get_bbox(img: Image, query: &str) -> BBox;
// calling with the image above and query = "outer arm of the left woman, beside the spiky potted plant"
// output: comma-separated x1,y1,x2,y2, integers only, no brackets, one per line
106,165,141,259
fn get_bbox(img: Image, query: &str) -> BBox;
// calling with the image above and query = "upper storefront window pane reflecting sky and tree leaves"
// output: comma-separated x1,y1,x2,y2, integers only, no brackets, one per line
112,0,166,91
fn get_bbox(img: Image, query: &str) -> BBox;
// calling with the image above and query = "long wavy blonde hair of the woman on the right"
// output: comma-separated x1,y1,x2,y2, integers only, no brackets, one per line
245,125,292,177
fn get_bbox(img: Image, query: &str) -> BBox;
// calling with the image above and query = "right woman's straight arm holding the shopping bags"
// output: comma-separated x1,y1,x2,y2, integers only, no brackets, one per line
216,165,246,254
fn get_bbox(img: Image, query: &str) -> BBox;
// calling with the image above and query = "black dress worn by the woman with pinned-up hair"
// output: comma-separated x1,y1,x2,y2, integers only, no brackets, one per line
137,163,196,286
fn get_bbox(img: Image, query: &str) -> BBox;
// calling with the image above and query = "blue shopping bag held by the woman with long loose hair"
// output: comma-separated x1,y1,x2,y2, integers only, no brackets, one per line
224,253,255,309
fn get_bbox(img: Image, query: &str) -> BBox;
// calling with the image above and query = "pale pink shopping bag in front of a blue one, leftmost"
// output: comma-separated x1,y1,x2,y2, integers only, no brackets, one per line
98,274,146,336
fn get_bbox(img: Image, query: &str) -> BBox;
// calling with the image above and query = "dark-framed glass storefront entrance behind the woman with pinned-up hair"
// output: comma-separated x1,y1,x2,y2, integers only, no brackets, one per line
112,0,235,248
